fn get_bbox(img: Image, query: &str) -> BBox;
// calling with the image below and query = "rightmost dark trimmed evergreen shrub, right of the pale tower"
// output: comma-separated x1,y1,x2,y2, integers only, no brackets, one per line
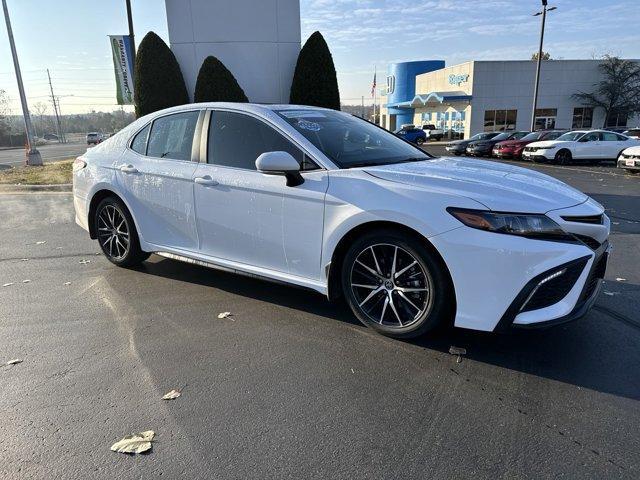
289,32,340,110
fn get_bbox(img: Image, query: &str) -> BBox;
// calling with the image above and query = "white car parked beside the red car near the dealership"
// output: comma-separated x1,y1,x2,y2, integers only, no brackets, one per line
522,130,640,165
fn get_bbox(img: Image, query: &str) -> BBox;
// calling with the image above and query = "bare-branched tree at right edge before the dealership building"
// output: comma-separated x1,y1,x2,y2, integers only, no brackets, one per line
573,55,640,126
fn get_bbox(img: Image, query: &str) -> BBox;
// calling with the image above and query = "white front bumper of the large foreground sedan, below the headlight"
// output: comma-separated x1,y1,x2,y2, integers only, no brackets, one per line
429,200,610,331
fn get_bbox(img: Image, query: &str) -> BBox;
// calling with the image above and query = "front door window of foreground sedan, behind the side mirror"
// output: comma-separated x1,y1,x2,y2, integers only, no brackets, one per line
207,111,318,170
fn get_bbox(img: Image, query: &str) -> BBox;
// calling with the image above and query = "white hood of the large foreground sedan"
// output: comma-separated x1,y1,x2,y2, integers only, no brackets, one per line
364,157,588,213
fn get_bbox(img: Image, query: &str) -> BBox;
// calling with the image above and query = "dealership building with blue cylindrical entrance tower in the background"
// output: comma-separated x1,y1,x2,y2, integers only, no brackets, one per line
379,60,640,138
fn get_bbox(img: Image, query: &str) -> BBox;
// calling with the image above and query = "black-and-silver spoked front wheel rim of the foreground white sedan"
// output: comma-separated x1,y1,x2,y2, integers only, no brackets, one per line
349,243,433,329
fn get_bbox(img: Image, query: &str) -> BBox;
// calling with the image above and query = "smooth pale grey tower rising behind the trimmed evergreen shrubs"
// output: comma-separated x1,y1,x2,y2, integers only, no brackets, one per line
165,0,300,103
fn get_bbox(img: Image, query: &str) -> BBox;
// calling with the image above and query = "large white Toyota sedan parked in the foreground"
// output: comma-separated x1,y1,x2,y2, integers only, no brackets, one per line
73,103,609,338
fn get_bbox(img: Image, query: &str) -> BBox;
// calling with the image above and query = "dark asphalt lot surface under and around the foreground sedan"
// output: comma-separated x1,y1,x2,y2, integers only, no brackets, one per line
0,158,640,479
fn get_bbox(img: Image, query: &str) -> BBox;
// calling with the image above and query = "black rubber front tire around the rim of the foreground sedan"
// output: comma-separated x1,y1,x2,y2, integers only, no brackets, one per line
340,230,454,338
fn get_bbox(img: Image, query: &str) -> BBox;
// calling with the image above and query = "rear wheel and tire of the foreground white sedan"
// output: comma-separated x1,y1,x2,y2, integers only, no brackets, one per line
93,197,151,267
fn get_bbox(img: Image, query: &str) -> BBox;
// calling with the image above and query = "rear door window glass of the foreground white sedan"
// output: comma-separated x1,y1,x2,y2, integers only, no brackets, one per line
147,111,200,160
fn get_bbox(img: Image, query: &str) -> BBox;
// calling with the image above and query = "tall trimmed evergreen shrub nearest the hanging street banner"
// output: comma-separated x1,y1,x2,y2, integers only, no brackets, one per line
133,32,189,117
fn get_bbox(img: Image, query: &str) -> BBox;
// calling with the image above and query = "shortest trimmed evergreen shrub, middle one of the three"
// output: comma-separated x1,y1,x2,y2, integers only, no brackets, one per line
193,56,249,103
